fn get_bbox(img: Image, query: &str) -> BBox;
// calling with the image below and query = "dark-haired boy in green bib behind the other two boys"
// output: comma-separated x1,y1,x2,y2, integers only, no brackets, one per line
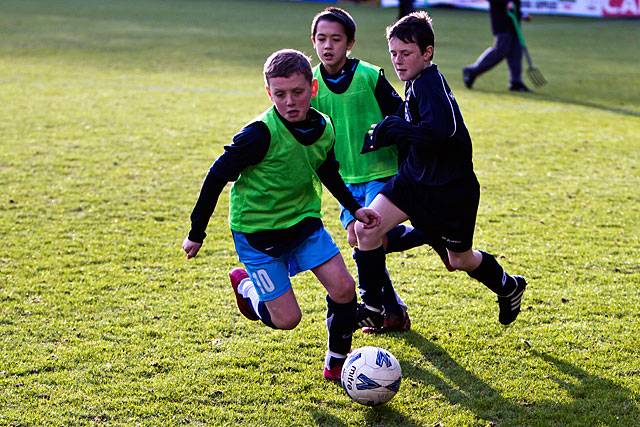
311,7,450,332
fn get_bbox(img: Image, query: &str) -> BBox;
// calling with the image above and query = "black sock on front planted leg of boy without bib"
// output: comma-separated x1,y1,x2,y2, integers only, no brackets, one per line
353,246,391,310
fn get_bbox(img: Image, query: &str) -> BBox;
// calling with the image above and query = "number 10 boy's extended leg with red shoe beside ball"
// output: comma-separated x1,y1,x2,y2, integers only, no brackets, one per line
311,254,356,380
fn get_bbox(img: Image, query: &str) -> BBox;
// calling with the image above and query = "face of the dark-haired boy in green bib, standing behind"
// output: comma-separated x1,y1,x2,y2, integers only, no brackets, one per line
311,20,355,74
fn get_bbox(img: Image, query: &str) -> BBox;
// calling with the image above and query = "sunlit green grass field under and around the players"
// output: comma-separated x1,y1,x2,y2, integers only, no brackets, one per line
0,0,640,426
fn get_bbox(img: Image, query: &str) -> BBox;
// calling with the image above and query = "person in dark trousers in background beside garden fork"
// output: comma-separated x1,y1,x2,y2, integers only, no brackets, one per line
462,0,531,92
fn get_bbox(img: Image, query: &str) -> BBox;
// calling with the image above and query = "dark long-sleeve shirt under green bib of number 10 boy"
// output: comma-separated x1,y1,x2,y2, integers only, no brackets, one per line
188,109,361,246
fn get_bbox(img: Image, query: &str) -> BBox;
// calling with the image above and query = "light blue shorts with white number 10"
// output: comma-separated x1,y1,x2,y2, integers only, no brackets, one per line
231,227,340,301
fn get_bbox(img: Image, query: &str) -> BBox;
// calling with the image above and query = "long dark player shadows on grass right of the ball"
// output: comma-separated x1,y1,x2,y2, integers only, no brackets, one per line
402,331,640,425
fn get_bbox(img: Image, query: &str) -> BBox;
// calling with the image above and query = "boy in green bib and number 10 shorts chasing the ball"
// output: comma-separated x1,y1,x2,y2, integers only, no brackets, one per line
183,49,380,381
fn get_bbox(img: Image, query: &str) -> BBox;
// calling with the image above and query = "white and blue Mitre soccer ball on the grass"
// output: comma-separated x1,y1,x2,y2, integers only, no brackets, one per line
341,346,402,406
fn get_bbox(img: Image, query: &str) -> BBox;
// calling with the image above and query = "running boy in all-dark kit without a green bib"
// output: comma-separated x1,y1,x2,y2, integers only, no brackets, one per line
356,12,527,325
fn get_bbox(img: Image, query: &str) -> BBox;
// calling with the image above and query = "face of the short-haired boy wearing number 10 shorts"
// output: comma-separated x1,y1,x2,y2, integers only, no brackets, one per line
267,73,318,122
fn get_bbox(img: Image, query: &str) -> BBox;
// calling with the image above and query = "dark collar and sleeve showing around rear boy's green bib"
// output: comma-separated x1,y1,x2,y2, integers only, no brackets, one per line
320,58,402,117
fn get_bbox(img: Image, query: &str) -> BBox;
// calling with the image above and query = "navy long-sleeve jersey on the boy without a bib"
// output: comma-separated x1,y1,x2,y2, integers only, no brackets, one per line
364,64,474,186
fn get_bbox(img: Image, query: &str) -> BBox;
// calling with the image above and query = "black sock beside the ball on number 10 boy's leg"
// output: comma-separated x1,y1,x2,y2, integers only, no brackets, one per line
327,294,357,367
